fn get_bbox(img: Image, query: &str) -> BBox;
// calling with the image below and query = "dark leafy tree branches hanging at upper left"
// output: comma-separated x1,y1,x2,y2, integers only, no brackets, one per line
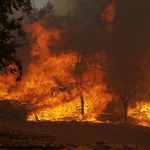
0,0,32,80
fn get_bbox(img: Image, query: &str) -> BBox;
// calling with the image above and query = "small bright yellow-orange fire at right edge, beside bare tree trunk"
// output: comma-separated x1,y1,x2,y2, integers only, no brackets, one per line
128,102,150,126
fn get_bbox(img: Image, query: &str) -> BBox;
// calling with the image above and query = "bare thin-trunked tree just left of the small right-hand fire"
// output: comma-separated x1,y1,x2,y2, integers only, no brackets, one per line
105,51,148,124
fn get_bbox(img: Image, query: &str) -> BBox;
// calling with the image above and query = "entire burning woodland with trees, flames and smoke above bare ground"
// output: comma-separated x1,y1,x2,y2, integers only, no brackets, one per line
0,0,150,126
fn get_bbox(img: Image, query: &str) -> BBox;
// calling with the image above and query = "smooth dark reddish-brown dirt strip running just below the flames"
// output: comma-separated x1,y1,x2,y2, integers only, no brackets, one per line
0,120,150,150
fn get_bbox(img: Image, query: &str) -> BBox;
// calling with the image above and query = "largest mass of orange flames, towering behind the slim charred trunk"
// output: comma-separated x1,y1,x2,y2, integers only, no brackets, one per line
0,18,112,121
